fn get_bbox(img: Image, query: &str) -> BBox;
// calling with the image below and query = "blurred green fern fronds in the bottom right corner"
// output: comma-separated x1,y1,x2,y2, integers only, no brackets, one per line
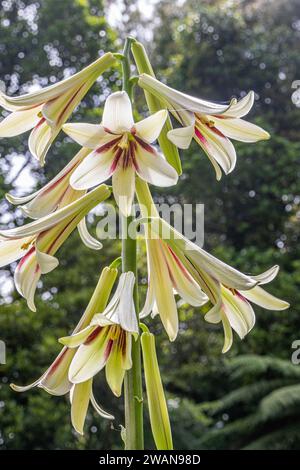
199,355,300,450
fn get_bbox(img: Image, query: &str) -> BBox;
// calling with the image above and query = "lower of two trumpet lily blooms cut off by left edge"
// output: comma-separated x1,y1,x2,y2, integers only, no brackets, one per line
0,185,110,311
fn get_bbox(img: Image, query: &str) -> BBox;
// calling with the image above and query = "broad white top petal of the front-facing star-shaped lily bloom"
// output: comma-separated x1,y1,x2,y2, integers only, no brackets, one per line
102,91,134,133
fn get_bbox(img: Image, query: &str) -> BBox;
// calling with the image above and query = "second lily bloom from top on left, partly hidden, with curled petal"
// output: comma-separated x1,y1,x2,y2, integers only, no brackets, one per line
6,148,102,250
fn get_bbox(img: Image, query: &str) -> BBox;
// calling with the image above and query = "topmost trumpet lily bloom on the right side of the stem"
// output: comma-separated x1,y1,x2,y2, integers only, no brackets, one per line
139,74,270,180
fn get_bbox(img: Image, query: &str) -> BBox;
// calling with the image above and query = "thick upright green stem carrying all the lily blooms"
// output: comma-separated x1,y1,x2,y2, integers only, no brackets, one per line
122,38,144,450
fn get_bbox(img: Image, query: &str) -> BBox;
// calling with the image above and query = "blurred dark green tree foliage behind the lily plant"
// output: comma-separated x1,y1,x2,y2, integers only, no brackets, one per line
0,0,300,449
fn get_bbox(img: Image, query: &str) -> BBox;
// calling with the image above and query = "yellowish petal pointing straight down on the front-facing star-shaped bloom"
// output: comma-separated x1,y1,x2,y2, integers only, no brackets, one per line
112,166,135,217
